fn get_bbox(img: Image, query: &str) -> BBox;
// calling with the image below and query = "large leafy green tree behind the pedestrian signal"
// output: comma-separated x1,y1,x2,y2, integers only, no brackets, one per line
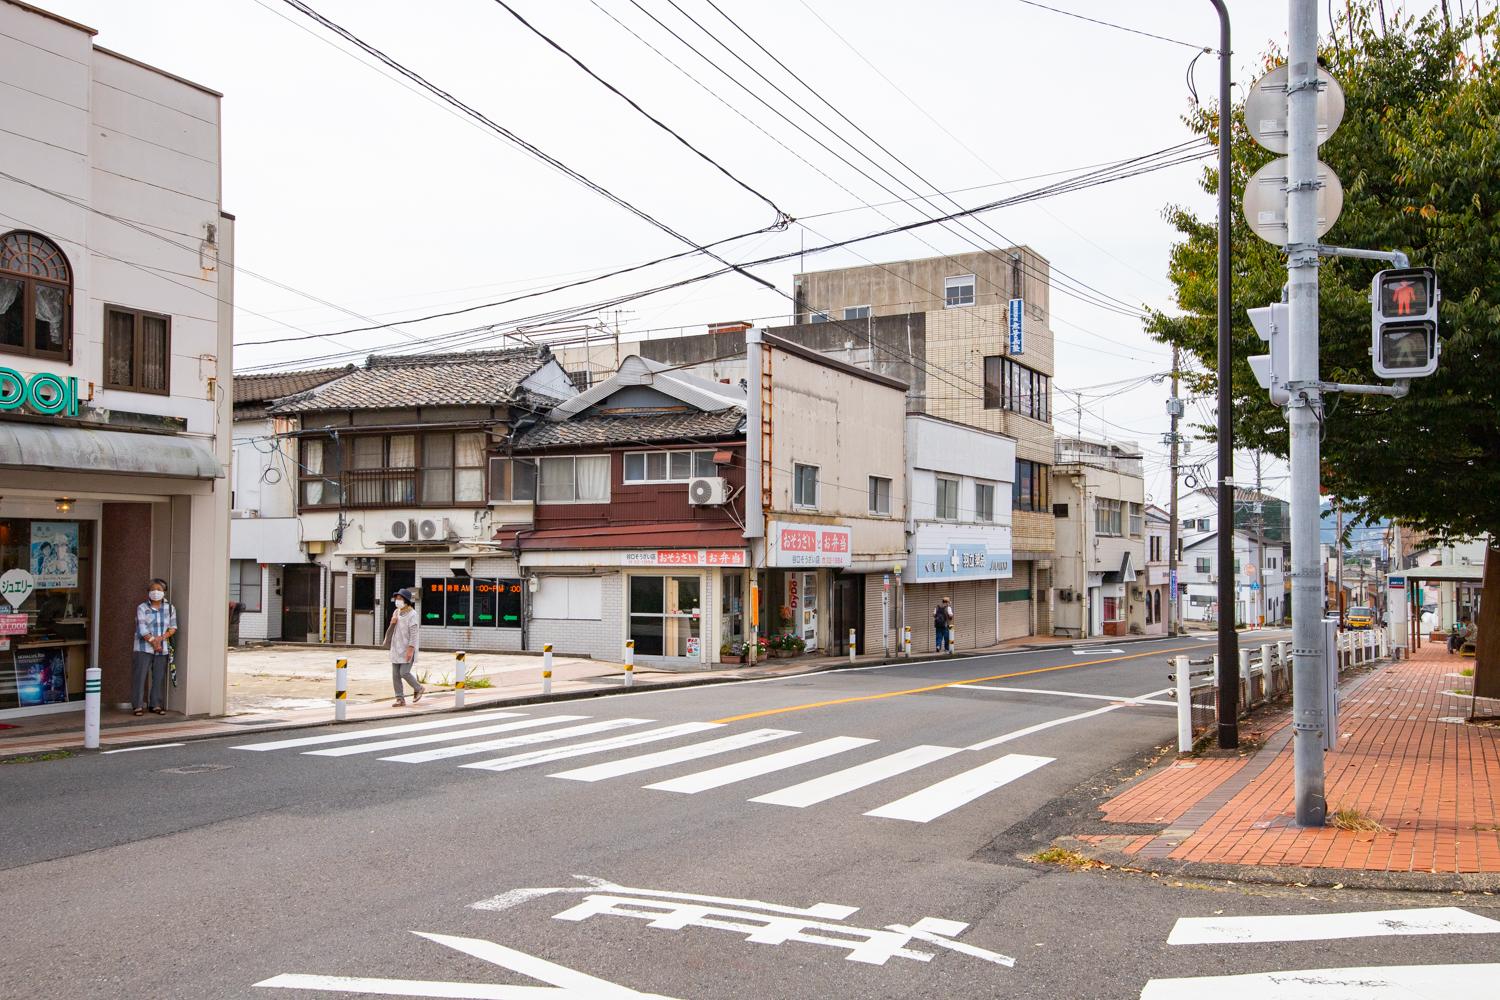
1148,3,1500,696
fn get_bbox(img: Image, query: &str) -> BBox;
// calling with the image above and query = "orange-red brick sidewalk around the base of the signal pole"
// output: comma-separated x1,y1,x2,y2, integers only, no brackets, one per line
1079,645,1500,873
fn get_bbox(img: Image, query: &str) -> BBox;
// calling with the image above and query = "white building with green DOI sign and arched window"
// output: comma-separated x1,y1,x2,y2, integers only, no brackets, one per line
0,0,234,718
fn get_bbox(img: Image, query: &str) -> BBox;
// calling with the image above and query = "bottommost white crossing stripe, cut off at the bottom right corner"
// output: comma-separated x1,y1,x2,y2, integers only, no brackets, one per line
1140,963,1500,1000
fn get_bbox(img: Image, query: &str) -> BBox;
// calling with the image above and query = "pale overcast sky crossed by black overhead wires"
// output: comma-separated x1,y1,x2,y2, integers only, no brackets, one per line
42,0,1428,504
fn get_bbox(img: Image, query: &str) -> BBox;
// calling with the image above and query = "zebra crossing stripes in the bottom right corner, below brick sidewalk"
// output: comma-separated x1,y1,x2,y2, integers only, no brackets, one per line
1140,907,1500,1000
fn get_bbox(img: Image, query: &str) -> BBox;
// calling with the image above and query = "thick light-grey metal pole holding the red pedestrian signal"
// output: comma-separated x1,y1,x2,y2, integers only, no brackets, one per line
1284,0,1328,826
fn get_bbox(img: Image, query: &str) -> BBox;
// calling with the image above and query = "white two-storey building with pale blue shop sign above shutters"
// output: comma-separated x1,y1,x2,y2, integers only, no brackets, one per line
902,414,1031,649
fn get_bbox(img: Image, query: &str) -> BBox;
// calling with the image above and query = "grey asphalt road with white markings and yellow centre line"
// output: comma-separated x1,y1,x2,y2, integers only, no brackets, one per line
0,639,1500,1000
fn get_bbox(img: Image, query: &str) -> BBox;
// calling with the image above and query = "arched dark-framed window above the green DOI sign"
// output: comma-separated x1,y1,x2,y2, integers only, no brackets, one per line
0,232,74,361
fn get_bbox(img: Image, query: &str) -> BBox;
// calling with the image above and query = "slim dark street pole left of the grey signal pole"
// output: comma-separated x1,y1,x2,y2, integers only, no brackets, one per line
1211,0,1242,750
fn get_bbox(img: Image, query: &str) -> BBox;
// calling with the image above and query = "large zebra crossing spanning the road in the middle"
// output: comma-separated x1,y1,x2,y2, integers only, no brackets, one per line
233,711,1053,823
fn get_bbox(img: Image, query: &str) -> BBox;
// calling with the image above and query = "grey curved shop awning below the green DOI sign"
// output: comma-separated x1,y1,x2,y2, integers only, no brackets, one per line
0,423,224,480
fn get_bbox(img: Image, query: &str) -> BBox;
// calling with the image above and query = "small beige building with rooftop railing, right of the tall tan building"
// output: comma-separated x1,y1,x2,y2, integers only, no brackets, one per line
1052,438,1146,637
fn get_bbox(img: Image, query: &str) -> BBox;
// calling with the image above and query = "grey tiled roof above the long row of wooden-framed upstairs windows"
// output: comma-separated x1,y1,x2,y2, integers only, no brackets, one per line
272,348,549,414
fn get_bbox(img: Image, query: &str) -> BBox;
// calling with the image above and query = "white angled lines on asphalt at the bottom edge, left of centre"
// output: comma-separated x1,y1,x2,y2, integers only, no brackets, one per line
255,931,672,1000
